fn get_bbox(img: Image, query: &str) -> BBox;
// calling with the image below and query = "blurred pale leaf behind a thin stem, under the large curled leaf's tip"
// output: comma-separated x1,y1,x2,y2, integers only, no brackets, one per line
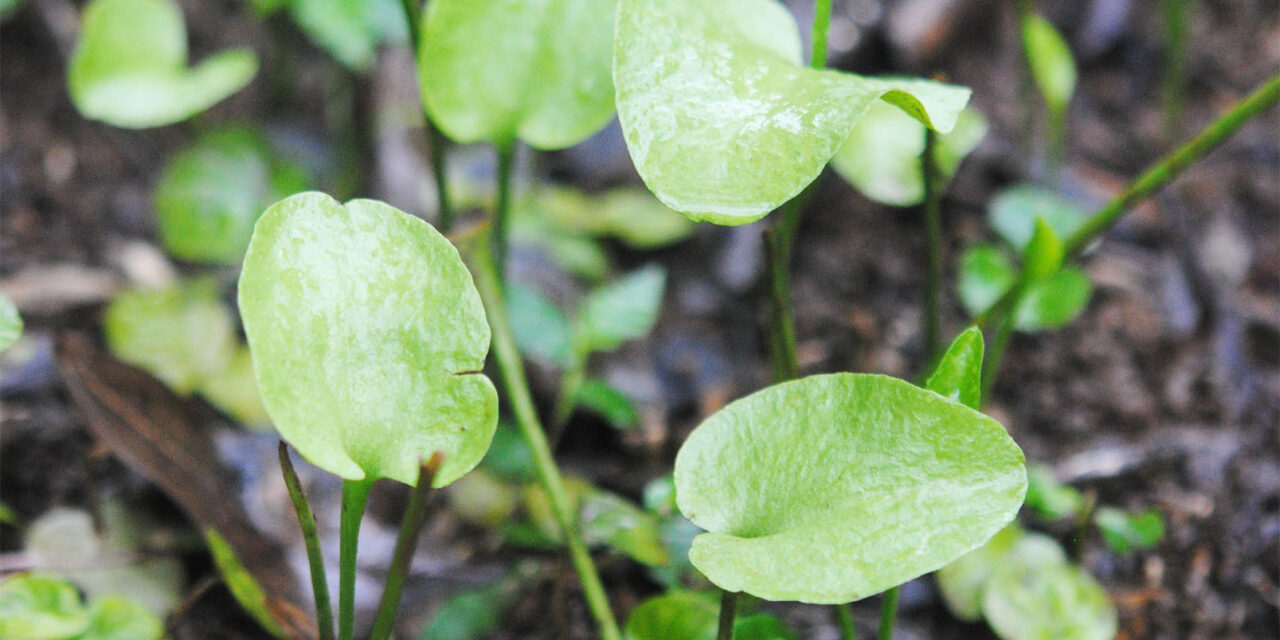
831,101,987,206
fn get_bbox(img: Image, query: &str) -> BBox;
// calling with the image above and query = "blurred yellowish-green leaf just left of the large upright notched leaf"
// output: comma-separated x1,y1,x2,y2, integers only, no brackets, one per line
102,279,237,394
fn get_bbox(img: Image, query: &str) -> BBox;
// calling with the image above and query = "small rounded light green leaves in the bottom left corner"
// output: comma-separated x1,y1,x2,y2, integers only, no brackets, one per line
0,573,164,640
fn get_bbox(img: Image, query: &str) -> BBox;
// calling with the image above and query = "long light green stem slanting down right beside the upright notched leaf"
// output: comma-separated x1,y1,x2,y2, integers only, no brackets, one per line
471,238,622,640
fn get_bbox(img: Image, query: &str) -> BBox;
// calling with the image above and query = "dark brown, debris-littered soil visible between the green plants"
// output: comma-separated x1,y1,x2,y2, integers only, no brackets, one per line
0,0,1280,639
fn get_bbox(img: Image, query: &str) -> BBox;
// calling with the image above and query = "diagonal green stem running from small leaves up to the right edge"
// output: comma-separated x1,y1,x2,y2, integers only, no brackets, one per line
1064,74,1280,256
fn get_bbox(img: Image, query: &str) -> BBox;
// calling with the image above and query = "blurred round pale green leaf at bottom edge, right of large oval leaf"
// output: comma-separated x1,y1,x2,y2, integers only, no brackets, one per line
982,535,1116,640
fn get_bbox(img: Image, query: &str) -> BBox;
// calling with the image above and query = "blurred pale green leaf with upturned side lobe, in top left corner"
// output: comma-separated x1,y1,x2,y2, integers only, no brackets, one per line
67,0,257,129
